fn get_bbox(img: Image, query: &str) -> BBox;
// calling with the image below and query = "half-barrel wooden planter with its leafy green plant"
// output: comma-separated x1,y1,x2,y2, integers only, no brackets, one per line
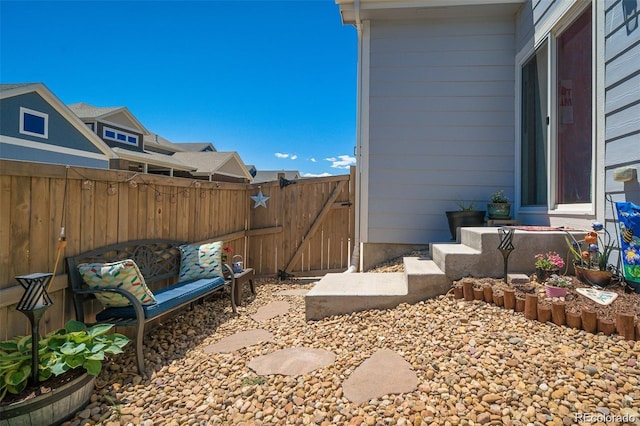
0,320,129,424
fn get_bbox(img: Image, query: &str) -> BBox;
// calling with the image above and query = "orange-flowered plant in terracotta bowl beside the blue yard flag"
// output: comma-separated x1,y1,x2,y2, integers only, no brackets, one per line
565,222,614,287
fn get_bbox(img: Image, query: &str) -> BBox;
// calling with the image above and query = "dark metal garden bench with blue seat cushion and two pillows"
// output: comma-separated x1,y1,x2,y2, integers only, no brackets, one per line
66,240,236,374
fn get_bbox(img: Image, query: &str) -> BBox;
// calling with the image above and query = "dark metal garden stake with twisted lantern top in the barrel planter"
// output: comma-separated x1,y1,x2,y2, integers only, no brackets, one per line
16,272,53,385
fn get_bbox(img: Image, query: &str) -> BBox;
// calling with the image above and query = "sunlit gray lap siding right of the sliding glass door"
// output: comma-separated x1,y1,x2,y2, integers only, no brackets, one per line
604,0,640,206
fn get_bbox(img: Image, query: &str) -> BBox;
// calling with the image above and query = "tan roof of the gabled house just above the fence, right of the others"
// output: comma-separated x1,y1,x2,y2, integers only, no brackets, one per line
172,152,252,180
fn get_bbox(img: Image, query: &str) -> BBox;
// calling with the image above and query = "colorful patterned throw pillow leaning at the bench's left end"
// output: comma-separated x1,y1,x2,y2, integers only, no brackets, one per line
78,259,156,307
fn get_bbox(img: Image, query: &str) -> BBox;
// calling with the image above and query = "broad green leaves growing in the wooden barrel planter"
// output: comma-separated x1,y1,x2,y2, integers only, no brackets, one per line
0,320,129,401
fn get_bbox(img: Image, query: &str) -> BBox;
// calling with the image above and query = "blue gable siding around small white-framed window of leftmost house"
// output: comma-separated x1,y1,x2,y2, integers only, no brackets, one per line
0,92,102,154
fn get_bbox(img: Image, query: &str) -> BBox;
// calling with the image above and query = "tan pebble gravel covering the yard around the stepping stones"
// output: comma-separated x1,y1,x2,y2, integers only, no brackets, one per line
61,280,640,426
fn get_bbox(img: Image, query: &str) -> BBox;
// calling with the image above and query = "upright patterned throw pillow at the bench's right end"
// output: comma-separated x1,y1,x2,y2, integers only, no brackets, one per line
179,241,222,281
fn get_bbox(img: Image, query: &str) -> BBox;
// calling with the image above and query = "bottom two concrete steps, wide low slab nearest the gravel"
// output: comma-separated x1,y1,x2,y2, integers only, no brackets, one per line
305,257,450,320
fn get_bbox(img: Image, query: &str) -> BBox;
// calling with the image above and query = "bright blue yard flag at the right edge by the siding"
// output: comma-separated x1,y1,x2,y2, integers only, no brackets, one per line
616,202,640,293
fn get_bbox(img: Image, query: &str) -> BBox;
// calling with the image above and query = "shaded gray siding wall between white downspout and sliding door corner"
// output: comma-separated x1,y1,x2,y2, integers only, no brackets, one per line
364,16,515,244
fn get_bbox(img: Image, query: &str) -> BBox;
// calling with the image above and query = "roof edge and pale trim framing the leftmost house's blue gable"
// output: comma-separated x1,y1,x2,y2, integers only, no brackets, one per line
0,83,115,161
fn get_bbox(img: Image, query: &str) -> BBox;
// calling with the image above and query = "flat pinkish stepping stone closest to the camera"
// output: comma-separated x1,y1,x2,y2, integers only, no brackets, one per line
342,349,418,404
